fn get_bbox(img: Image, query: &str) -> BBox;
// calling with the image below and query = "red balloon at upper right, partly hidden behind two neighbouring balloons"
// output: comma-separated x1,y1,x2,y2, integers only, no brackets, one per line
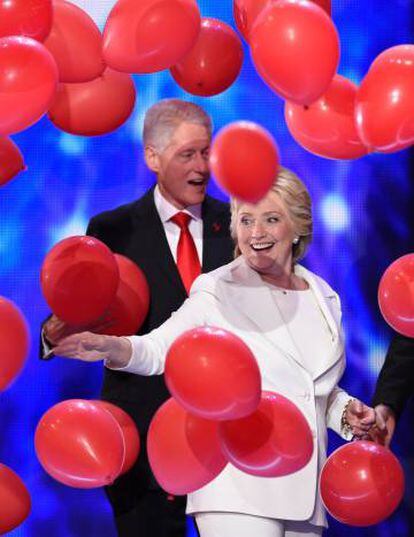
285,75,368,159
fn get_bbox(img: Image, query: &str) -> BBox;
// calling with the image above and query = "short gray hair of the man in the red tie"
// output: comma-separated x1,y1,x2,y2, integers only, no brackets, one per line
143,99,213,152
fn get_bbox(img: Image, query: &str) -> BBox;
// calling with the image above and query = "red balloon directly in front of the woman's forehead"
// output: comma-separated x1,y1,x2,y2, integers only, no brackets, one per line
210,121,279,203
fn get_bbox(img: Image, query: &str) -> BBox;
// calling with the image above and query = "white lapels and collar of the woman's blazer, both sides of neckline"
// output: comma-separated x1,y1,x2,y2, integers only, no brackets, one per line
225,256,342,379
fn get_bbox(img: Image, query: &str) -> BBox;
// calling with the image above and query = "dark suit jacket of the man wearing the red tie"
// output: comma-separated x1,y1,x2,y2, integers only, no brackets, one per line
86,189,233,502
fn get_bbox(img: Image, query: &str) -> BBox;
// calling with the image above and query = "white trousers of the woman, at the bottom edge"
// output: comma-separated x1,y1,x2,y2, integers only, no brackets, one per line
194,512,324,537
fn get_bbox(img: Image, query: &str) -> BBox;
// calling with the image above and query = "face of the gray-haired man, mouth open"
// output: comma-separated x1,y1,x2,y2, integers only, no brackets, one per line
147,123,211,209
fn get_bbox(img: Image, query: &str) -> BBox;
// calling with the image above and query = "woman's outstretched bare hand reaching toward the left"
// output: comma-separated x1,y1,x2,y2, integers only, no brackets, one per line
53,332,132,367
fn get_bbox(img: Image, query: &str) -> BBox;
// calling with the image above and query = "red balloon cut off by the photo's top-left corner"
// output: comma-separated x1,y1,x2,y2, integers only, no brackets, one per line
0,0,53,41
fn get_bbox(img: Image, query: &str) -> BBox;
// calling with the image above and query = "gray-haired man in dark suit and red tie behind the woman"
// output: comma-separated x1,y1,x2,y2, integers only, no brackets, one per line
43,99,232,537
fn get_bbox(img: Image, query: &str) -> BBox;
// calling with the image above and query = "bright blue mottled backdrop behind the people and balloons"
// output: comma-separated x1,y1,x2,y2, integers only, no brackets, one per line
0,0,414,537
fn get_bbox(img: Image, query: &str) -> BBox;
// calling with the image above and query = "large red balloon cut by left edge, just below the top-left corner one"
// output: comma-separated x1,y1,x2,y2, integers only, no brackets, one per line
0,37,58,135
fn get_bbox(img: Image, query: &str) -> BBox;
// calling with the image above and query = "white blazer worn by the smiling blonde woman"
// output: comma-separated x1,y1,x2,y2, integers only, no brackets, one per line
119,256,350,525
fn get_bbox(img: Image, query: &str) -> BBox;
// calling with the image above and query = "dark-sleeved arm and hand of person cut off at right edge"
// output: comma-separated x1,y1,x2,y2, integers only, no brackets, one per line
373,334,414,446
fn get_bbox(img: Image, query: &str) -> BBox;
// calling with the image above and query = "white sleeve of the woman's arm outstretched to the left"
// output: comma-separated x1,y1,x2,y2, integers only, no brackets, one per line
106,274,217,376
